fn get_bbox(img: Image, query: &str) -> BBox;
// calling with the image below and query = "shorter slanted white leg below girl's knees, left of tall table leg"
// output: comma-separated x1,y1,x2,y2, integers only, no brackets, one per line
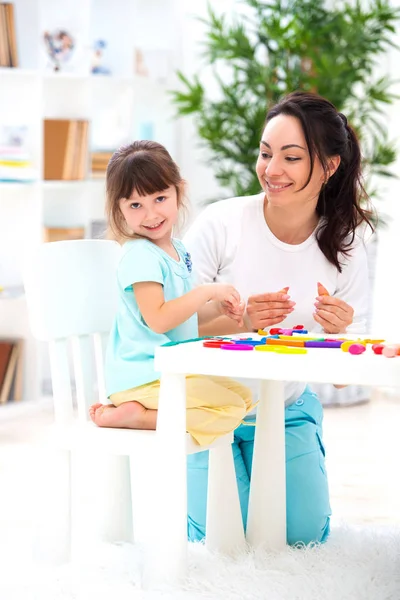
206,444,245,555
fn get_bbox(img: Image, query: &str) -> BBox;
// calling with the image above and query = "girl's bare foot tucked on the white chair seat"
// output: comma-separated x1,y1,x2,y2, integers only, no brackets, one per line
89,402,157,429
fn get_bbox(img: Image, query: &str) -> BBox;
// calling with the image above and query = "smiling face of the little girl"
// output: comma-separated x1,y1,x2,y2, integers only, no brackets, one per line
120,186,178,244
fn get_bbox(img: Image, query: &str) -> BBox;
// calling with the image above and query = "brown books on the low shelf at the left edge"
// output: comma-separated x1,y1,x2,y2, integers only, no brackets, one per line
0,339,24,404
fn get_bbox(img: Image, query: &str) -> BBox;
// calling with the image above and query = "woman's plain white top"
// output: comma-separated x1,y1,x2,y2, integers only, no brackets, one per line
183,193,369,404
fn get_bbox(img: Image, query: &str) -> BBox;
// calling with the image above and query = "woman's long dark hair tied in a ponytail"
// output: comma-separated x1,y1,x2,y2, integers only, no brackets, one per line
266,92,373,272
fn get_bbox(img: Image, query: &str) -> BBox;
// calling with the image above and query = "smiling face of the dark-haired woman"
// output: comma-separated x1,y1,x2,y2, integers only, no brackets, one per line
256,115,325,208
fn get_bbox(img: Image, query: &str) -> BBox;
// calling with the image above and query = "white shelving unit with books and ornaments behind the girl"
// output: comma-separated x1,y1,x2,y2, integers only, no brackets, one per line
0,0,180,398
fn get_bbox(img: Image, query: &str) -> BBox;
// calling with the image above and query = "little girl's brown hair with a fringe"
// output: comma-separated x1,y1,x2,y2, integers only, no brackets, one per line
106,140,185,241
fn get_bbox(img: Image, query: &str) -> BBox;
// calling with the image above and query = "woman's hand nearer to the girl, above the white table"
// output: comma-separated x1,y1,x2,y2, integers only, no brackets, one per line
247,288,296,330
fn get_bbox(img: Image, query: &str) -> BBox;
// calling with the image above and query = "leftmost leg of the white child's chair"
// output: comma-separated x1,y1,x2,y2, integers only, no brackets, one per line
33,447,71,565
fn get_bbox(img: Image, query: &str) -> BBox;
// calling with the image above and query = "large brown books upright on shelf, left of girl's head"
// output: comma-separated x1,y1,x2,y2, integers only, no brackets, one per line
44,119,89,180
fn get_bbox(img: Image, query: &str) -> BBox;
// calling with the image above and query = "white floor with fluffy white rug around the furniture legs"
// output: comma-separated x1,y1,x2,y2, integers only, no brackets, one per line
0,392,400,600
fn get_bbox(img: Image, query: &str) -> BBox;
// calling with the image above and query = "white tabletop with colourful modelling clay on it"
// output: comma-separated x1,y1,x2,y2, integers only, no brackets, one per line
155,334,400,387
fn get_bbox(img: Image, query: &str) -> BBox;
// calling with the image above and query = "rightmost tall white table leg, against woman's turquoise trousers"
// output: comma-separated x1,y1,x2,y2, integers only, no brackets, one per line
247,381,286,550
